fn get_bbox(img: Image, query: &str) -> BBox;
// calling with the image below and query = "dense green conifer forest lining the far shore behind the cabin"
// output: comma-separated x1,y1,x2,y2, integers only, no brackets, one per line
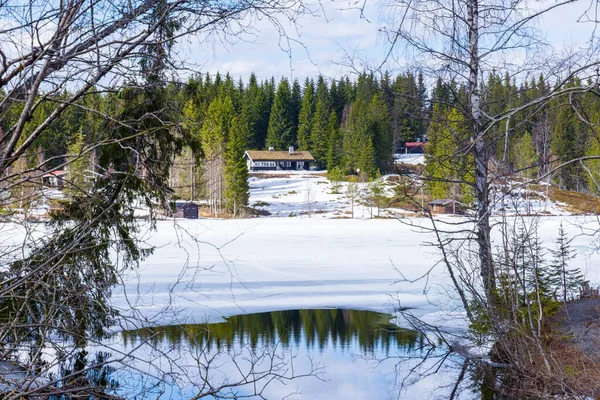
1,73,600,208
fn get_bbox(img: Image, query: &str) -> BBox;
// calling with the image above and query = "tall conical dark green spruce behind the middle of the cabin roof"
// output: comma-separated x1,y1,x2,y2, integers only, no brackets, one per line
267,78,296,150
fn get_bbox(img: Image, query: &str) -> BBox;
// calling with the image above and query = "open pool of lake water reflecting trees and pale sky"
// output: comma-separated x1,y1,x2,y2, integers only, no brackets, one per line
114,309,472,400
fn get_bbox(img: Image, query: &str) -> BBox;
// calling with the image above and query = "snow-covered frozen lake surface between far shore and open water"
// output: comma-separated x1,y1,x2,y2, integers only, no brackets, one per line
113,217,600,328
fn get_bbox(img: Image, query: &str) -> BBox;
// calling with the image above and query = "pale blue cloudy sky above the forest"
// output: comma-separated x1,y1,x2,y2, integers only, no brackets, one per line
179,0,594,81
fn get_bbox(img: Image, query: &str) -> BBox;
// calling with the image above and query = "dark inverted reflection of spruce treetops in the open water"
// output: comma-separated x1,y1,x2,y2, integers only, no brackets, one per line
121,309,424,353
